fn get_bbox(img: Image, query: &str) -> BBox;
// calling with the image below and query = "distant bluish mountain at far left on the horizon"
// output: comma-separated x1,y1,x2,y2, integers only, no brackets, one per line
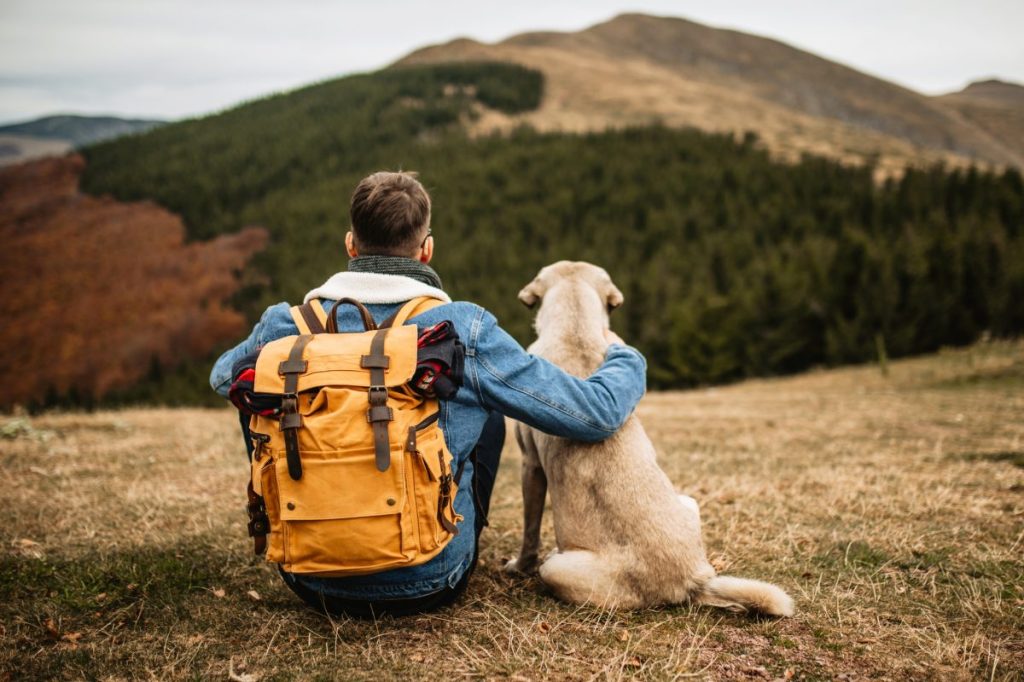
0,115,165,166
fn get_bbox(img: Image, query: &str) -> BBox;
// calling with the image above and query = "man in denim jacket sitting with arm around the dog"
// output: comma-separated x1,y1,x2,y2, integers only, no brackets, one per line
210,172,646,617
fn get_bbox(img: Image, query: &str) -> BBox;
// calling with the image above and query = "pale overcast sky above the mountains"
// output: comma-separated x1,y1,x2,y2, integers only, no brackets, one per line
0,0,1024,122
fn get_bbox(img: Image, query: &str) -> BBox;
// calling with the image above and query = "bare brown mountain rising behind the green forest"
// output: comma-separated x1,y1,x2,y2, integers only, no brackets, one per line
397,14,1024,171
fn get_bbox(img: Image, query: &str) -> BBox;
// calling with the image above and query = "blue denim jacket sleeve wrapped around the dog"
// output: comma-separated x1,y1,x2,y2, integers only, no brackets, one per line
467,310,647,441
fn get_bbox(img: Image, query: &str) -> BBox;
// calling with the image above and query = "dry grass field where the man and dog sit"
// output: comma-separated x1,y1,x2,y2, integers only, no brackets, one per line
0,342,1024,680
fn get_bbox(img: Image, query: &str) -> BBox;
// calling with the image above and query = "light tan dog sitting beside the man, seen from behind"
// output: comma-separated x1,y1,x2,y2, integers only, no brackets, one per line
506,261,793,615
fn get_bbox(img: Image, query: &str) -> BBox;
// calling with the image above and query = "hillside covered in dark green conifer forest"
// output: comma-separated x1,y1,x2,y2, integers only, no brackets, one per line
72,59,1024,401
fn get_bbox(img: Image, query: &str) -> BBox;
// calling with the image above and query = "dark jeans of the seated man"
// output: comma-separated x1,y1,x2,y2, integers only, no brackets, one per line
264,413,505,619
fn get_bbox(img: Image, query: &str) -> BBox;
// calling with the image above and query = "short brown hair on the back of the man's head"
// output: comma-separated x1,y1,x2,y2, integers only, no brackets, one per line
348,171,430,256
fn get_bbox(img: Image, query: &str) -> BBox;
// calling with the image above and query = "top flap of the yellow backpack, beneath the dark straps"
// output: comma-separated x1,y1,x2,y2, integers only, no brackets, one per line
254,325,418,394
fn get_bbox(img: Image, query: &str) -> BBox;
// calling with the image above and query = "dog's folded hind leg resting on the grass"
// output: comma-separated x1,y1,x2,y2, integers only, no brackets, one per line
541,550,643,608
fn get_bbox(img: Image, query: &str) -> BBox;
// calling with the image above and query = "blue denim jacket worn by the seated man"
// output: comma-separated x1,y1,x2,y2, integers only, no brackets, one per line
210,300,647,600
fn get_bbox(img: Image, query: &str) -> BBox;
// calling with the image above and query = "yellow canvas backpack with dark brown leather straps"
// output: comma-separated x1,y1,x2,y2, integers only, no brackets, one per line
243,298,462,577
